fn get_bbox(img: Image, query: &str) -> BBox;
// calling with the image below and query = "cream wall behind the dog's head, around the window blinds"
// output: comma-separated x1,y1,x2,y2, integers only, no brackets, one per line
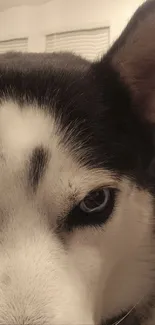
0,0,144,52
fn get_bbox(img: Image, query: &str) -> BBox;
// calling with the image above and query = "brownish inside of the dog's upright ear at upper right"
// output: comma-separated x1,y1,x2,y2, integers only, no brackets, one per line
102,0,155,123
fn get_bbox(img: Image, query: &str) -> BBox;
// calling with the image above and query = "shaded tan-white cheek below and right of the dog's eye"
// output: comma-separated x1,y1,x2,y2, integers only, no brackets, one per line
68,179,153,323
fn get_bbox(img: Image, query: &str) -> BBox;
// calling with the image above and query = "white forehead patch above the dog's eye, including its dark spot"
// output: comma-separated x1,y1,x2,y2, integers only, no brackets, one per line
0,101,114,211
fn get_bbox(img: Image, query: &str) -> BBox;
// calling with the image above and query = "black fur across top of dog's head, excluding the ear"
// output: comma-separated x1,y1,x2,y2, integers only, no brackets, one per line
0,53,154,191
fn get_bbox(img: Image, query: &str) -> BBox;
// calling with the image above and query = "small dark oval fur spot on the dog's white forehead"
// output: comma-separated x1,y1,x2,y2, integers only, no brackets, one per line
29,146,48,191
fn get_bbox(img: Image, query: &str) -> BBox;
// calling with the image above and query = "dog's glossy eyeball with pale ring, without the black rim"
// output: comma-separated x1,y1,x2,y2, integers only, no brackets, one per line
80,188,110,213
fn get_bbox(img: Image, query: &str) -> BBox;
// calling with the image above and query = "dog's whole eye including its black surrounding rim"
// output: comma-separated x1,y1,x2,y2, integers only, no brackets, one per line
64,187,118,231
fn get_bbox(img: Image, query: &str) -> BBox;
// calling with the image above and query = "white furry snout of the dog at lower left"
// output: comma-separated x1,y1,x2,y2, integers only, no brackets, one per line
0,227,93,325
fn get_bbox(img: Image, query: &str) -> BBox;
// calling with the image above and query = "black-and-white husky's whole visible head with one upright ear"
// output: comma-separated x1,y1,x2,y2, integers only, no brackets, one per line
0,1,155,325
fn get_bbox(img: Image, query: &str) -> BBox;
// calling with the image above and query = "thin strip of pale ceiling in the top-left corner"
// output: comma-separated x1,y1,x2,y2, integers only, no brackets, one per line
0,0,49,11
